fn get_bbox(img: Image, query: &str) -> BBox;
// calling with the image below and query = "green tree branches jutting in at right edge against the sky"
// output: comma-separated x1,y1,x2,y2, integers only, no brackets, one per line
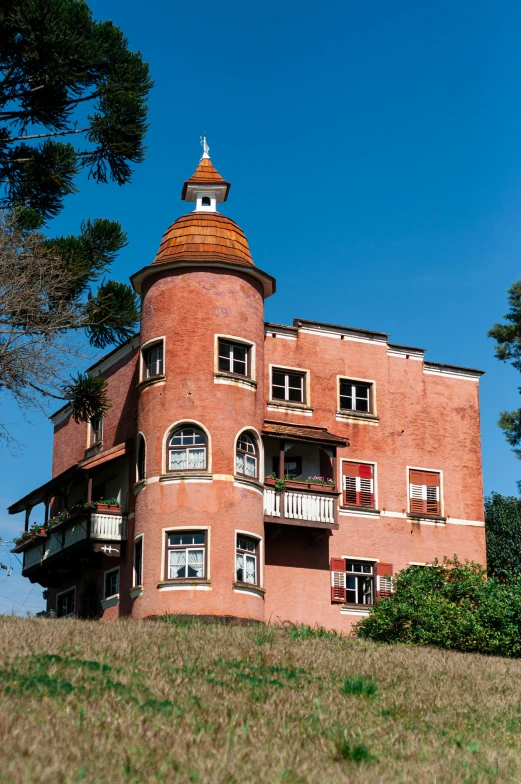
488,280,521,458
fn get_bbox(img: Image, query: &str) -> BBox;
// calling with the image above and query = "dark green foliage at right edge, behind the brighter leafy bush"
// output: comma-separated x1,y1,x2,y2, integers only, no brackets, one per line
485,493,521,578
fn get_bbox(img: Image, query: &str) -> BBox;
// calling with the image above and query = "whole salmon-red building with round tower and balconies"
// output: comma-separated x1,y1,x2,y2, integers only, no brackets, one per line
9,145,485,631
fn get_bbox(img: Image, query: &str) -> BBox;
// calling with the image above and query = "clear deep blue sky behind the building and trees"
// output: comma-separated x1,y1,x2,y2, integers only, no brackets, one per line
0,0,521,612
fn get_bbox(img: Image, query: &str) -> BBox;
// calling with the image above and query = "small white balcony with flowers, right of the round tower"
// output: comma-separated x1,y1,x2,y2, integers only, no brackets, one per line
264,479,339,530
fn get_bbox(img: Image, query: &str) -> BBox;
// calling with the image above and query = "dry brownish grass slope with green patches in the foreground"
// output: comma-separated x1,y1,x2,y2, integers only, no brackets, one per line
0,616,521,784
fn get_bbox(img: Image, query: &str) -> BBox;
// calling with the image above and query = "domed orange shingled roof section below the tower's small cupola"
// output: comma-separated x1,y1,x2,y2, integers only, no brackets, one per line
154,213,255,267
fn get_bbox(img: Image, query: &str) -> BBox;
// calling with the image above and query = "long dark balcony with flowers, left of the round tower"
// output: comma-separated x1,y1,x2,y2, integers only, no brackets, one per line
15,510,127,584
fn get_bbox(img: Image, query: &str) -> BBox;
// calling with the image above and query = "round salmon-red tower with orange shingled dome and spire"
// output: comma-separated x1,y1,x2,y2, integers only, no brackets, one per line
132,139,275,620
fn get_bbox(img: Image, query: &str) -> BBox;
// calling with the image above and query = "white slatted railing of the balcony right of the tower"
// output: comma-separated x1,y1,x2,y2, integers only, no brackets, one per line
264,487,338,528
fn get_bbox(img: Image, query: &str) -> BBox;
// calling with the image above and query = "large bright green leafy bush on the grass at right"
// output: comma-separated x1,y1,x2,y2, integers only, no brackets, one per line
355,556,521,658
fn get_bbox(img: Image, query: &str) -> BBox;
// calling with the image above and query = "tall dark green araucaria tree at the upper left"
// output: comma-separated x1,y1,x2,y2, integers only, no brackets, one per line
0,0,152,438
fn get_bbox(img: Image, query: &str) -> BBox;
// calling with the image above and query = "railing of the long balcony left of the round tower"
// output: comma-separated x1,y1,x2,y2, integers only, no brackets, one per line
24,512,127,571
